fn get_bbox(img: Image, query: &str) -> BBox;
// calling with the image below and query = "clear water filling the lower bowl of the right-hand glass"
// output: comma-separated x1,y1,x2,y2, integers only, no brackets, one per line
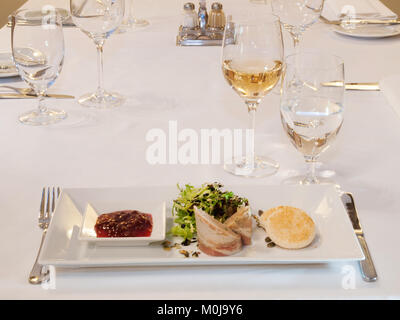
281,97,343,157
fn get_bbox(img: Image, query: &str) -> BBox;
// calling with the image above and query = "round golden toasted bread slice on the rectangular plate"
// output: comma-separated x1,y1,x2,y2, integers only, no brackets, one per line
260,206,315,249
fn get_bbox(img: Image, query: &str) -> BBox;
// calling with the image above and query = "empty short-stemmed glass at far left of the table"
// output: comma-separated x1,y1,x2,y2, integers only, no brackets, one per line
11,9,67,126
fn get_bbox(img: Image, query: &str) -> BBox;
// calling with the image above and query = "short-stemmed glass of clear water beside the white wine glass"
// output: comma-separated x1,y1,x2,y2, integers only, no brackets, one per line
281,52,344,184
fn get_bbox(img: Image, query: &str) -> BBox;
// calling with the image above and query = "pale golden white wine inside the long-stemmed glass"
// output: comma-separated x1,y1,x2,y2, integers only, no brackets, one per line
222,59,282,100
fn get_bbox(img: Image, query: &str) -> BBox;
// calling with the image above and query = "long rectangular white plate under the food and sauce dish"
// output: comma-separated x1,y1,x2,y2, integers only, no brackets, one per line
39,186,364,267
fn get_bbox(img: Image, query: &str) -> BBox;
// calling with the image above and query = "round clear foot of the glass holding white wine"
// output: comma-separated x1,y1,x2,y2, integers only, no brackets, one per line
224,156,279,178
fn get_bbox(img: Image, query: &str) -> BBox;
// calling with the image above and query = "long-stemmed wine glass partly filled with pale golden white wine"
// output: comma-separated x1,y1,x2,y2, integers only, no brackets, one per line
222,15,283,177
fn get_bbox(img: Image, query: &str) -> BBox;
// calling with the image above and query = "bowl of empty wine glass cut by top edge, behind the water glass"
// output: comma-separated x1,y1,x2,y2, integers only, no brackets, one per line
271,0,324,49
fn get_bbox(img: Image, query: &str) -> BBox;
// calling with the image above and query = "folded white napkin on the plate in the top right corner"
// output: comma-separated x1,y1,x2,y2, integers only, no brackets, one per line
324,0,397,19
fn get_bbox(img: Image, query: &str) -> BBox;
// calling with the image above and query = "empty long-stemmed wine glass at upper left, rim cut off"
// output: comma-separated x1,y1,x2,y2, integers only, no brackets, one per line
70,0,125,109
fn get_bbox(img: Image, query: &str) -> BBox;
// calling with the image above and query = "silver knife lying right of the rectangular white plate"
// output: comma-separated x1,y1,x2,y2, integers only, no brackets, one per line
342,192,378,282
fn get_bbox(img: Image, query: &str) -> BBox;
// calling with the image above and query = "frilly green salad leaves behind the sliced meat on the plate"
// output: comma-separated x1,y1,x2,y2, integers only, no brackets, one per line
170,182,249,240
